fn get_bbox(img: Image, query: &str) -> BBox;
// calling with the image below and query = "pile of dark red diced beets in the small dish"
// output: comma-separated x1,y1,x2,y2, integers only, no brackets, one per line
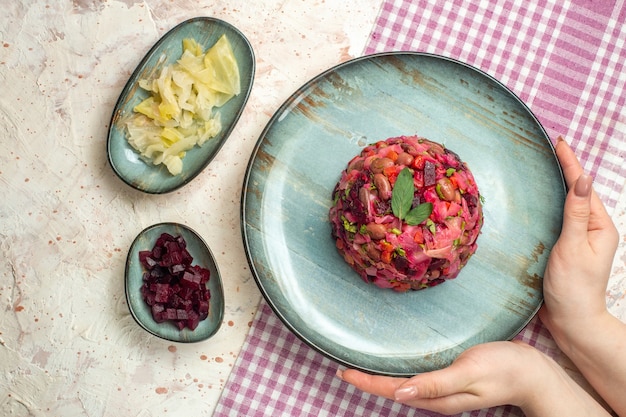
139,233,211,330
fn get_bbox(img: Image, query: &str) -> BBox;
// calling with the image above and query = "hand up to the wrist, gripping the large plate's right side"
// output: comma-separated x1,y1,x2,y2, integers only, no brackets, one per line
540,138,618,338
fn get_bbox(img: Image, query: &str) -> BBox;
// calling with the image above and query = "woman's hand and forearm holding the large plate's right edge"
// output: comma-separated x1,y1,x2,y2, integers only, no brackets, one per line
539,140,626,416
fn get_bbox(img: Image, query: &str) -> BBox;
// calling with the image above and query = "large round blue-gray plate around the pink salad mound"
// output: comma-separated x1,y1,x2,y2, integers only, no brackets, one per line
241,52,565,375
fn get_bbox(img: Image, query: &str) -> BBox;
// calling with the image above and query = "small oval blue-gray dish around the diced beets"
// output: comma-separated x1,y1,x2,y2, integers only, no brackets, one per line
125,223,224,343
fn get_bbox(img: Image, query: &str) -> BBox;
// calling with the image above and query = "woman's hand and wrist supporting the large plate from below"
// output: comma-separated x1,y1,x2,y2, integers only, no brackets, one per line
337,341,608,417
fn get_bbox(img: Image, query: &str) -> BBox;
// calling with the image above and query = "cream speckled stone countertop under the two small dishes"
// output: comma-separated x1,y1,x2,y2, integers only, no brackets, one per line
0,0,381,416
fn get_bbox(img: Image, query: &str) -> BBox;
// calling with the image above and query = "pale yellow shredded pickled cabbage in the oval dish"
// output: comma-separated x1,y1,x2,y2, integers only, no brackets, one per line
126,35,241,175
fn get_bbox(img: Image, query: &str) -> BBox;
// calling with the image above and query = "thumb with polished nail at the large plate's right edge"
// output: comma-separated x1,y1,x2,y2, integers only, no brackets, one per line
559,174,593,242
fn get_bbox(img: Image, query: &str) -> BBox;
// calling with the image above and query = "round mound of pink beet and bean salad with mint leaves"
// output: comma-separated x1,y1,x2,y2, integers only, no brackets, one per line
329,136,483,292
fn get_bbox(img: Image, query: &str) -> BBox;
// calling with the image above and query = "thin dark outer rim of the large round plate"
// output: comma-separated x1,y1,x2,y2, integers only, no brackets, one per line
240,50,568,377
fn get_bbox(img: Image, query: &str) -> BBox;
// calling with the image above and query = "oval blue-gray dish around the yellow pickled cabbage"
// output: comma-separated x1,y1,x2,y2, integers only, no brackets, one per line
107,17,255,194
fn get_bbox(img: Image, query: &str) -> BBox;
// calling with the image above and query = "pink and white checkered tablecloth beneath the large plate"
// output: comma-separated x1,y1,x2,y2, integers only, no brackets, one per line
214,0,626,417
